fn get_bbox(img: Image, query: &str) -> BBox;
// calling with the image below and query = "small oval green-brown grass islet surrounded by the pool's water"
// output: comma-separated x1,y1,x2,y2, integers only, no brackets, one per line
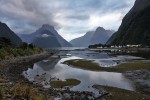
50,79,81,88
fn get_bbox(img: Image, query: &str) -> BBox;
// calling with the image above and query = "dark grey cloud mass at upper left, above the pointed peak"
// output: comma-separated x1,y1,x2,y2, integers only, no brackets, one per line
0,0,59,33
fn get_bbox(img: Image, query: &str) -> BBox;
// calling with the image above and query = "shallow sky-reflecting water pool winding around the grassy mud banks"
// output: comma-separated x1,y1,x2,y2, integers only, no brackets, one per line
23,50,137,92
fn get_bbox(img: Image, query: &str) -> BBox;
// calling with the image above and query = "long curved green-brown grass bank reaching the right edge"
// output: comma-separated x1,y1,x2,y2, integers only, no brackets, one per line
63,59,150,72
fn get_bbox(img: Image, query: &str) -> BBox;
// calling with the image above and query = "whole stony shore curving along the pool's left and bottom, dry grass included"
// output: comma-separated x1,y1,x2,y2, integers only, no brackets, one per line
0,52,99,100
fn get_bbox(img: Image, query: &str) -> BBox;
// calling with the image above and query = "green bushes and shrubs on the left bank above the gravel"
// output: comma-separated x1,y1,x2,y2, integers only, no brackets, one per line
0,38,42,60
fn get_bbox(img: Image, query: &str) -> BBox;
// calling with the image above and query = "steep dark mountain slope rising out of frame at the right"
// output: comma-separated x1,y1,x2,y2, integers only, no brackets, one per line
107,0,150,45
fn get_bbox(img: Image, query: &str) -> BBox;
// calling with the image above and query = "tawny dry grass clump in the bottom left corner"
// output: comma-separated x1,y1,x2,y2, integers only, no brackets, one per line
0,83,48,100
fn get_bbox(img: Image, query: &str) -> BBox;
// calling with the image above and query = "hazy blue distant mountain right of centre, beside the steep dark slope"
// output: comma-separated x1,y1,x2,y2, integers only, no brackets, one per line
70,27,114,47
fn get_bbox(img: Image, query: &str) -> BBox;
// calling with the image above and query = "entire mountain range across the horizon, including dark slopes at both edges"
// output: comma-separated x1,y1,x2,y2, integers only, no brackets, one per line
0,0,150,48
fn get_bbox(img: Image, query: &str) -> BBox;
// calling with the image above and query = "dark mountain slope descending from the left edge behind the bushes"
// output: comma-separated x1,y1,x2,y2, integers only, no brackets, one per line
0,22,22,45
